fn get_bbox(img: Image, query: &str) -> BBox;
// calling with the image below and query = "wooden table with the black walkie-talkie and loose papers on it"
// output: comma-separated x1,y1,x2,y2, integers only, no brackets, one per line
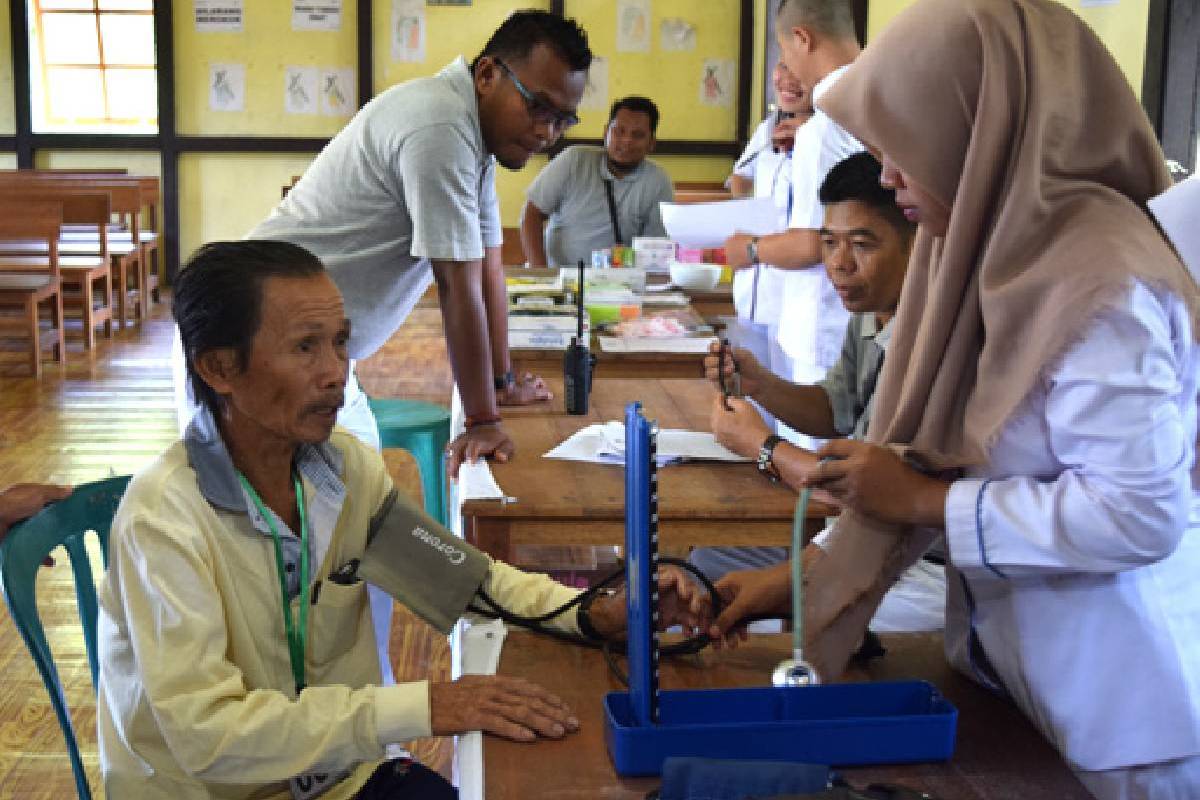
462,378,827,560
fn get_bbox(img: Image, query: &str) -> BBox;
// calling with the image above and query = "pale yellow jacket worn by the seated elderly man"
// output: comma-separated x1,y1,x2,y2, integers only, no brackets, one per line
97,429,577,800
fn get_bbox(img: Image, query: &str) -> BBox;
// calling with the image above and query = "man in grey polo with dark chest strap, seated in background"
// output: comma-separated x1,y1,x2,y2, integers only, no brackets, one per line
521,97,674,266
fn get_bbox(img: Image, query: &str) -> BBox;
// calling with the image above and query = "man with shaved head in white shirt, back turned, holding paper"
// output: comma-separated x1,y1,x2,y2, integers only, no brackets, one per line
725,0,864,438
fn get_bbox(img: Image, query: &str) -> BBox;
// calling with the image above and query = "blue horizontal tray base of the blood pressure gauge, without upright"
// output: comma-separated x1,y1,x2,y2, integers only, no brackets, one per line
604,681,959,776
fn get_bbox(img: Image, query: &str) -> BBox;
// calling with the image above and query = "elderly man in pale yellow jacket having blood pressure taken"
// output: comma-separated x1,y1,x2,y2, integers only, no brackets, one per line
97,241,695,800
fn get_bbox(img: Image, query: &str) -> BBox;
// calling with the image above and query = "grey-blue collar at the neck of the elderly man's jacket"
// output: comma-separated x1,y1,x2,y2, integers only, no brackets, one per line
184,407,346,534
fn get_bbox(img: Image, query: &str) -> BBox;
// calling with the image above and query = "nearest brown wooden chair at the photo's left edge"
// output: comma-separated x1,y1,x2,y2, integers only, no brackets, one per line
0,197,67,378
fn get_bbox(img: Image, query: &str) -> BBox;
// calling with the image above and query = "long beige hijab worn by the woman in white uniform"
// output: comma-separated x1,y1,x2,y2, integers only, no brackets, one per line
805,0,1200,676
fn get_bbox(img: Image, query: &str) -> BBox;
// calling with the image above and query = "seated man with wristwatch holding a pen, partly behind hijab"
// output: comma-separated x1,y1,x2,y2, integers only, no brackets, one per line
691,152,946,631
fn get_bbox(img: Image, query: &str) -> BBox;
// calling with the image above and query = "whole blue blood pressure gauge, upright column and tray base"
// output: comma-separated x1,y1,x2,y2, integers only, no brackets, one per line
604,403,958,776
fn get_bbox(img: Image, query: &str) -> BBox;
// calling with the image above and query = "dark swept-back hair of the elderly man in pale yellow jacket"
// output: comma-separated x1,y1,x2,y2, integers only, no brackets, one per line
172,240,325,416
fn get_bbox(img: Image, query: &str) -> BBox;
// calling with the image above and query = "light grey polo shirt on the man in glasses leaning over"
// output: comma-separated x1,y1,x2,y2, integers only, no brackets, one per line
250,58,503,359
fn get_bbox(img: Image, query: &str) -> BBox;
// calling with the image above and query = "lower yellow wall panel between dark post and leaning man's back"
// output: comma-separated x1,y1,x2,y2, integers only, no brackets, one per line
179,154,312,259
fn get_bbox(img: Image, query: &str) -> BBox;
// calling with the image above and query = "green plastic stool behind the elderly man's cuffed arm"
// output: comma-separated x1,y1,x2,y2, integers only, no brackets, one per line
370,397,450,525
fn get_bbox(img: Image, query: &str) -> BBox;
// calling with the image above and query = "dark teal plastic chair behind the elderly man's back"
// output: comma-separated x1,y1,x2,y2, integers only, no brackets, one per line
0,475,130,800
